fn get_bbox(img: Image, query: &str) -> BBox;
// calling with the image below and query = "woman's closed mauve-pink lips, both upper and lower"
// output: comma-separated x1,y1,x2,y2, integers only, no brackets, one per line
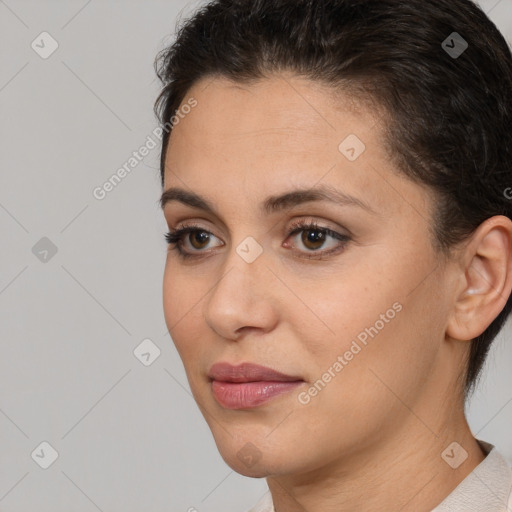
208,363,304,409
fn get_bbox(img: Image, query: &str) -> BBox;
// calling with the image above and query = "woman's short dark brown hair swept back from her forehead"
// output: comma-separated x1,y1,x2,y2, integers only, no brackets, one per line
155,0,512,398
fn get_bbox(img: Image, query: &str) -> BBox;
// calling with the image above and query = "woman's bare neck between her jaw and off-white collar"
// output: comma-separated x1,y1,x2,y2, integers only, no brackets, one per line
267,412,485,512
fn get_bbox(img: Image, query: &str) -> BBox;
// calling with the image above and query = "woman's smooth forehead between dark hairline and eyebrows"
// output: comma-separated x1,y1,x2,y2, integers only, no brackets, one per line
164,77,423,219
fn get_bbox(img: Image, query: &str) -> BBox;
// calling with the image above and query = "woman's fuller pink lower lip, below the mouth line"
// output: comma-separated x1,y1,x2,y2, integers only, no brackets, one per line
212,380,304,409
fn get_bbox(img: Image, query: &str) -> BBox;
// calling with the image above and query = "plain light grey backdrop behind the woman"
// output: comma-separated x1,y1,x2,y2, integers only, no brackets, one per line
0,0,512,512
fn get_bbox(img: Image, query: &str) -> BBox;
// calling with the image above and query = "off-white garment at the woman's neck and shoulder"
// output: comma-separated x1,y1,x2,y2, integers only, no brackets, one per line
248,439,512,512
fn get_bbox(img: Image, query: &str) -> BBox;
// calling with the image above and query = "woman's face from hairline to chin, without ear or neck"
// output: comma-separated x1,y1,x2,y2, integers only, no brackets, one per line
163,75,455,477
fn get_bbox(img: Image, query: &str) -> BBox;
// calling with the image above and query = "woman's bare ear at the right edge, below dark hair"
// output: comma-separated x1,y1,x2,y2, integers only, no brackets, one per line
446,215,512,341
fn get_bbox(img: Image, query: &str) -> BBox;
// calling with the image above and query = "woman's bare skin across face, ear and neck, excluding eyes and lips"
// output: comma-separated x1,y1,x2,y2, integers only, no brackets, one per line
163,74,512,512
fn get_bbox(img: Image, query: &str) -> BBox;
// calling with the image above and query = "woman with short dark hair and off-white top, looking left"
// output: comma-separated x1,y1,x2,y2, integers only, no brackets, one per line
156,0,512,512
